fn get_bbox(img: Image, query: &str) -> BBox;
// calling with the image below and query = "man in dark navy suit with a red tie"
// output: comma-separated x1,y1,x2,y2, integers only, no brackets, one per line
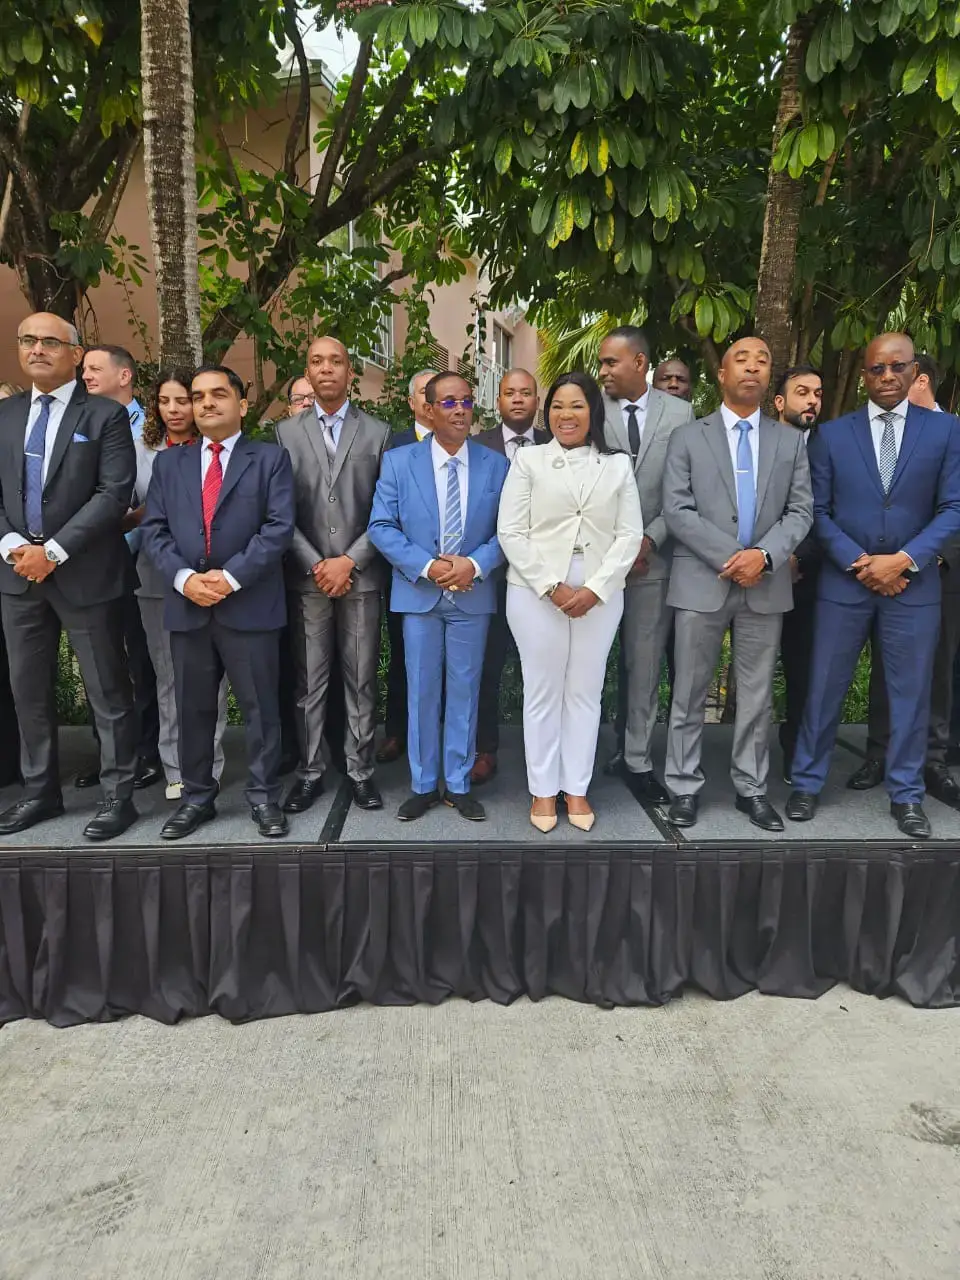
141,365,296,840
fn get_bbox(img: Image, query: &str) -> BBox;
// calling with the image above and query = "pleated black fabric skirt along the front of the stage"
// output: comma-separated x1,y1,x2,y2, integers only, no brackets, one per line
0,846,960,1027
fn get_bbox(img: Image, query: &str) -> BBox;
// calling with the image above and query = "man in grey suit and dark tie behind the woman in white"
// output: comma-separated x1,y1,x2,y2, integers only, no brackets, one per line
600,325,694,804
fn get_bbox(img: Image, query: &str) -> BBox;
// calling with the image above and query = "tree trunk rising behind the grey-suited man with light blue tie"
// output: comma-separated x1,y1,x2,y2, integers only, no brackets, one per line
756,15,812,396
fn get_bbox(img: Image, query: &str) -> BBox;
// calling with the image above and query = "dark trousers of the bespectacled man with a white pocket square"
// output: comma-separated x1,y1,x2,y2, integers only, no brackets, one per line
0,586,137,800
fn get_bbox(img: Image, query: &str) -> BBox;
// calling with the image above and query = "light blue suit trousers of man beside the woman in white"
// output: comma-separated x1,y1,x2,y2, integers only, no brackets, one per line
403,594,490,795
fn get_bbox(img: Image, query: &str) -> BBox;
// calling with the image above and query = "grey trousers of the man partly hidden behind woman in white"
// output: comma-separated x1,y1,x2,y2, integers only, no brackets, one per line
621,577,673,773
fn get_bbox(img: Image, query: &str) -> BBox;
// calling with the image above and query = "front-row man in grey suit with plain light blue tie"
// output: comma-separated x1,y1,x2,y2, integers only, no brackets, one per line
663,338,813,831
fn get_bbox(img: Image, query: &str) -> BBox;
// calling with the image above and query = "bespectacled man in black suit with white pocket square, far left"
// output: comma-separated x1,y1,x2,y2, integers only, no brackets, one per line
0,312,137,840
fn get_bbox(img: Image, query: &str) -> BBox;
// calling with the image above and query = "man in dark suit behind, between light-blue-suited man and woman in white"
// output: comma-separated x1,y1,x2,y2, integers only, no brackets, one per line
470,369,550,787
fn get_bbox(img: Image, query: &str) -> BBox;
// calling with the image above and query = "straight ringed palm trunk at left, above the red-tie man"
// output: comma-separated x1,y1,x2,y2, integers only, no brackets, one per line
141,0,201,367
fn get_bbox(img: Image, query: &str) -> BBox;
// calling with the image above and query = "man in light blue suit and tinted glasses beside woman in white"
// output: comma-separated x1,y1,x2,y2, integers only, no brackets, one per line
369,374,509,822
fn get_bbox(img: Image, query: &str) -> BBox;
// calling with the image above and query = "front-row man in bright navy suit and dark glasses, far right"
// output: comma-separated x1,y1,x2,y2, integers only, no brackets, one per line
787,333,960,840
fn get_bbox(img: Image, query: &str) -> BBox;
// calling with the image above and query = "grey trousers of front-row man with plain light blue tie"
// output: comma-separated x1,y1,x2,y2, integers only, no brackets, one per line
664,588,783,796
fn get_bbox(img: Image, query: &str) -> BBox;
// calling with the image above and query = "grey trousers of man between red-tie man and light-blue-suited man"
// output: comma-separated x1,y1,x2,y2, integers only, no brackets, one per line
288,591,380,782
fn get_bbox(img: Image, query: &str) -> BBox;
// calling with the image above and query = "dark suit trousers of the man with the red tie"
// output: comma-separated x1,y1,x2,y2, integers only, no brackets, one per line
170,613,280,805
